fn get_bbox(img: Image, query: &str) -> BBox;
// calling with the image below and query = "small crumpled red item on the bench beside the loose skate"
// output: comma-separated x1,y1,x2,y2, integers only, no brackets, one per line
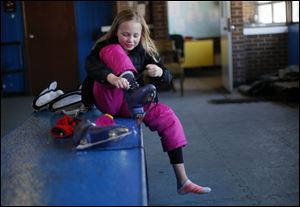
51,115,79,139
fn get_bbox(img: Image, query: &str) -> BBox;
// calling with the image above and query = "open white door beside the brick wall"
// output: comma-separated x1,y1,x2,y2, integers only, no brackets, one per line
220,1,234,93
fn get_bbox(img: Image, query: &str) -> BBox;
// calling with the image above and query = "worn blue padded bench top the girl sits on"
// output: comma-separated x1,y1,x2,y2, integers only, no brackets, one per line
1,110,148,206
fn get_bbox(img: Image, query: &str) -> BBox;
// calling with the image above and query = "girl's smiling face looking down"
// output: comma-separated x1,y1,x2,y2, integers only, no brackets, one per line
117,20,142,51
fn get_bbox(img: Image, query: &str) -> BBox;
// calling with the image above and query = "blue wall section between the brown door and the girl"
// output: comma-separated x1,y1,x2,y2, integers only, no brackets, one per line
74,1,112,82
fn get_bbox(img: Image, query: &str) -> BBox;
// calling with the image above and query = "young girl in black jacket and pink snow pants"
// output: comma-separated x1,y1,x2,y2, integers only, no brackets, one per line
82,10,211,194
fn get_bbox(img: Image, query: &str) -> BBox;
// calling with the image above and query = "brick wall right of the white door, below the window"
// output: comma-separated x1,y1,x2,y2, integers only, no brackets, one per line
231,1,288,86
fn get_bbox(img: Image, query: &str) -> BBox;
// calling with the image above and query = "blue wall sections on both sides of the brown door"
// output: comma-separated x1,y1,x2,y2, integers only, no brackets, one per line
1,1,112,93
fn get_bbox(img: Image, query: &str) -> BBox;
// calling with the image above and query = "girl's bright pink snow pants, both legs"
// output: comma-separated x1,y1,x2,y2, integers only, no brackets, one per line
93,44,187,151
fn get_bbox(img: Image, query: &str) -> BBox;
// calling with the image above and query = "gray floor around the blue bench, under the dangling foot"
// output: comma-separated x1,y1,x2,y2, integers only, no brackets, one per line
1,77,299,206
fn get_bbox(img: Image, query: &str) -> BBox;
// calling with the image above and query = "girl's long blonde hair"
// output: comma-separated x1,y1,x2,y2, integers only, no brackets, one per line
93,9,158,60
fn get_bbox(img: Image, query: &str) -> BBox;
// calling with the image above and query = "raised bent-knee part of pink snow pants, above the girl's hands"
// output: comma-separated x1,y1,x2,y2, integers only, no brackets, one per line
99,44,137,76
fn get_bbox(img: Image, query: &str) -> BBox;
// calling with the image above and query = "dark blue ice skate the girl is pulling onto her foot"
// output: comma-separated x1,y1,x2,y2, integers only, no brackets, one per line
121,72,156,120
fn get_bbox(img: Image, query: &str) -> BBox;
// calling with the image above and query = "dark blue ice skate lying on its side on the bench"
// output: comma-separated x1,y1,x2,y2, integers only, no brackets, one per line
73,120,131,150
